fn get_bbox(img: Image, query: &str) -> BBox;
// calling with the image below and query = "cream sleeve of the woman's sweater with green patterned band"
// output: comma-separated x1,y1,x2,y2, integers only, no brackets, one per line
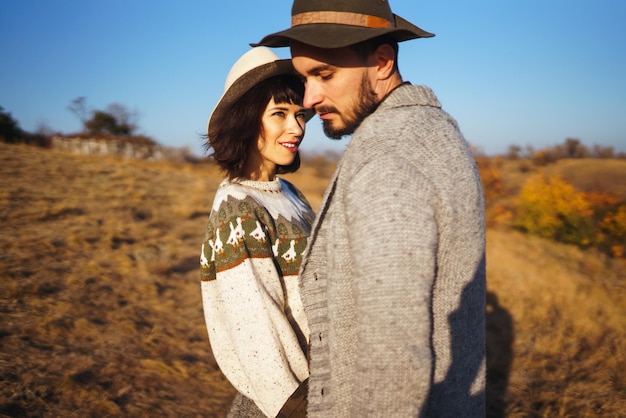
201,199,308,416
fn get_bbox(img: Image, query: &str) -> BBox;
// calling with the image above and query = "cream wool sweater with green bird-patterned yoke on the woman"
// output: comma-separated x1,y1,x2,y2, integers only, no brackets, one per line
200,178,314,417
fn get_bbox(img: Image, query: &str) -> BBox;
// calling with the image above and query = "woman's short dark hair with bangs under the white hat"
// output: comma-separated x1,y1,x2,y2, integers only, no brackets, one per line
205,75,304,180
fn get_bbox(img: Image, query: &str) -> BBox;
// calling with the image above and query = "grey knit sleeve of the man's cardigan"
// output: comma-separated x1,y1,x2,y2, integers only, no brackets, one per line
345,156,437,416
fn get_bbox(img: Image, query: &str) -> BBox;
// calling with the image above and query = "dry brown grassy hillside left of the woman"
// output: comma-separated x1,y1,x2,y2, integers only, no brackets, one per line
0,144,234,417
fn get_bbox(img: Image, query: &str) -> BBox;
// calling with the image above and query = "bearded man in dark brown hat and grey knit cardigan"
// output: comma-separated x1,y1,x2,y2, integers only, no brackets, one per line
251,0,485,417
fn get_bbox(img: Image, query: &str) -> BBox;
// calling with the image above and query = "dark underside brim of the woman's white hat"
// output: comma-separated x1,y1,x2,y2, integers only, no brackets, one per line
207,59,315,138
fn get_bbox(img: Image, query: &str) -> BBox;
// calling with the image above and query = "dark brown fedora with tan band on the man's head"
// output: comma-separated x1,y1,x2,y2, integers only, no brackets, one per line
251,0,435,48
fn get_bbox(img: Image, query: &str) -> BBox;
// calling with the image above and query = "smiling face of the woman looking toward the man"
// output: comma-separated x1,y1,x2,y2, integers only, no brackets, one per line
250,98,306,181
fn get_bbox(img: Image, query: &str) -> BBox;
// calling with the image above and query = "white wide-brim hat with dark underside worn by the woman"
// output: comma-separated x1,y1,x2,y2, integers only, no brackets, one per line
207,46,313,139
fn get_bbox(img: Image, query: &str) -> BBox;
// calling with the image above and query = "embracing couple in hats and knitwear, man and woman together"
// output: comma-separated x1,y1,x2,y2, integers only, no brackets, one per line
200,0,485,417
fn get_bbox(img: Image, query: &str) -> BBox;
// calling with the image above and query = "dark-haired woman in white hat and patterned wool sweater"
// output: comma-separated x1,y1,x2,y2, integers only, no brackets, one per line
200,47,314,417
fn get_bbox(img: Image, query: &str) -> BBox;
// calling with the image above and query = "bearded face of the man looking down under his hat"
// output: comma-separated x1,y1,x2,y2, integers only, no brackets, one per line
291,42,378,139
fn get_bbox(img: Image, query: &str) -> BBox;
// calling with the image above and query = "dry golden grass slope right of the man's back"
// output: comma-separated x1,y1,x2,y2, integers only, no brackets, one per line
487,229,626,417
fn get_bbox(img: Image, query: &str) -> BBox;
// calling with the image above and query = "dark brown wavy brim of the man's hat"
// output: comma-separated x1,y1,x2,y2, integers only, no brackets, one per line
250,15,435,48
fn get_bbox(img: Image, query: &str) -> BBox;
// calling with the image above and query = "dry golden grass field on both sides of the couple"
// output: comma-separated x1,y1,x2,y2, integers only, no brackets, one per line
0,143,626,417
